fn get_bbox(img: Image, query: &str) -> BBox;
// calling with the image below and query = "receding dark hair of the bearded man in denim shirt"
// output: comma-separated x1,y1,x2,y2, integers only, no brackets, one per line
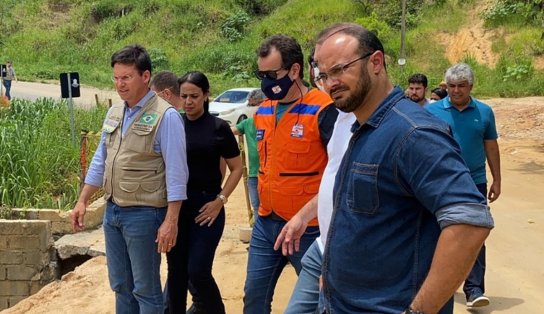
316,23,386,68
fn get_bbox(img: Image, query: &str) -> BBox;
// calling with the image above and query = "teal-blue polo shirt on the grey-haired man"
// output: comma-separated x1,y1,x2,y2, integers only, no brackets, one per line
425,97,498,184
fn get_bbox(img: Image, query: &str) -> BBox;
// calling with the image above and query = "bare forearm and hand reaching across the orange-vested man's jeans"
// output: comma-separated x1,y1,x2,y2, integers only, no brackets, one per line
274,194,318,256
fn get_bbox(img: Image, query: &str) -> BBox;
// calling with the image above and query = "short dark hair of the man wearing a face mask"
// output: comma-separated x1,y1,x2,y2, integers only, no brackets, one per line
256,35,304,79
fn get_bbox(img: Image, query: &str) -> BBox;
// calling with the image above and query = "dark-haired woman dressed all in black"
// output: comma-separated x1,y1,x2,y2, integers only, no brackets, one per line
167,71,242,314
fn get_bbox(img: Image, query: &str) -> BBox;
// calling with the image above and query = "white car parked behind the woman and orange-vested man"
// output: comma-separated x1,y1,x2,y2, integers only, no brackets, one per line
210,87,259,126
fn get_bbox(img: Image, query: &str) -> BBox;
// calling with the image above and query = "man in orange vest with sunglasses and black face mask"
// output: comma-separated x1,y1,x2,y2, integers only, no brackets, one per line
244,35,338,314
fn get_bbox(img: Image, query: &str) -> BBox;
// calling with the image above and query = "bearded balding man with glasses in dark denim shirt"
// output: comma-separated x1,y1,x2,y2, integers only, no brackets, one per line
315,24,493,313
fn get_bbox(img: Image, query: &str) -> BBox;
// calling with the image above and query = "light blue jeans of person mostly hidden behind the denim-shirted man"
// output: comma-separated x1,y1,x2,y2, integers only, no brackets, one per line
284,240,322,314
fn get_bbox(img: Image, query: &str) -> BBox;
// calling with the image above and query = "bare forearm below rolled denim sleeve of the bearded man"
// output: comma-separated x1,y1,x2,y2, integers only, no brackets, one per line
410,224,490,314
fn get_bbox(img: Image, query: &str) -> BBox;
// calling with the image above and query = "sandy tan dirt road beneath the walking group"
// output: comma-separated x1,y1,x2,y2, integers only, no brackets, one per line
2,97,544,314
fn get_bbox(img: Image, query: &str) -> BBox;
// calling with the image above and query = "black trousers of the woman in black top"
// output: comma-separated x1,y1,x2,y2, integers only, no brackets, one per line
166,191,225,314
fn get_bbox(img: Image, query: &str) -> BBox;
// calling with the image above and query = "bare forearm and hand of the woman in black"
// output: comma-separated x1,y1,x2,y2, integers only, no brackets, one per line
195,155,243,226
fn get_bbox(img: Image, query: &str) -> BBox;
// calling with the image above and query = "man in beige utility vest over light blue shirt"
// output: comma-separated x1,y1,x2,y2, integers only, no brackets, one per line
71,45,188,314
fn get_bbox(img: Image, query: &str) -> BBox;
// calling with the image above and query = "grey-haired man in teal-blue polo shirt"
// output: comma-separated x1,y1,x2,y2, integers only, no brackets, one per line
426,63,501,307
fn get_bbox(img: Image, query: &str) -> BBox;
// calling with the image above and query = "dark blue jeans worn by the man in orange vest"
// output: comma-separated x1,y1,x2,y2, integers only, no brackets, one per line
244,216,319,314
